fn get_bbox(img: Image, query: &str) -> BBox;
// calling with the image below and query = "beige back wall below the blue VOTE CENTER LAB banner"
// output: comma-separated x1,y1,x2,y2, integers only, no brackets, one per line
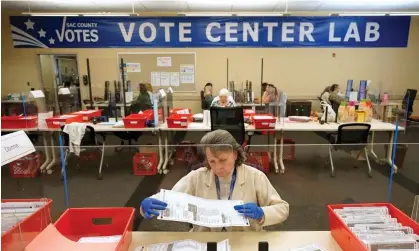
1,12,419,111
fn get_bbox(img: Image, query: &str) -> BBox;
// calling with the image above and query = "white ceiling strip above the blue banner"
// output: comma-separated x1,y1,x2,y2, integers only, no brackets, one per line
1,0,419,12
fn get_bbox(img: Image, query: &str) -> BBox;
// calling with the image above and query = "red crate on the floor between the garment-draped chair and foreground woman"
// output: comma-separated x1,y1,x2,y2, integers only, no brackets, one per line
132,153,158,176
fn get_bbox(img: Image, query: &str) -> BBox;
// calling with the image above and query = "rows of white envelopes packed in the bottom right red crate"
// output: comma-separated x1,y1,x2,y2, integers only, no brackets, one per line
334,206,419,251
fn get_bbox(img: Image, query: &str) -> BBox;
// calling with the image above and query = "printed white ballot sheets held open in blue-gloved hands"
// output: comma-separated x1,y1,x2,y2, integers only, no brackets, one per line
157,189,249,227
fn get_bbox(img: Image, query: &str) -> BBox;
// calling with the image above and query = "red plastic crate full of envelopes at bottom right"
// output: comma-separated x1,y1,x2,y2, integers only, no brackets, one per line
327,203,419,251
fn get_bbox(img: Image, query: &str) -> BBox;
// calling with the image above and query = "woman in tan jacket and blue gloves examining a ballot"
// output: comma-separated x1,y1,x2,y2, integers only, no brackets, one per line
140,130,289,232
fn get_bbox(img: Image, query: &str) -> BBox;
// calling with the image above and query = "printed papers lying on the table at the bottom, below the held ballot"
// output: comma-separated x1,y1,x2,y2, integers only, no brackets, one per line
135,240,231,251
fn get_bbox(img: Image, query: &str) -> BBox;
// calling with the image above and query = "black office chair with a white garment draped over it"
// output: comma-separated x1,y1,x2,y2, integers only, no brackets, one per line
61,126,108,180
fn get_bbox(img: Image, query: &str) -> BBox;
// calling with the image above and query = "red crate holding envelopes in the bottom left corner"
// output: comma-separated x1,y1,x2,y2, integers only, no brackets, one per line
1,199,52,251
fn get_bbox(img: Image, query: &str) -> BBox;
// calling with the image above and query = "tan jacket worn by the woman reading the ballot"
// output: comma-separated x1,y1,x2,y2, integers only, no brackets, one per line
141,165,289,232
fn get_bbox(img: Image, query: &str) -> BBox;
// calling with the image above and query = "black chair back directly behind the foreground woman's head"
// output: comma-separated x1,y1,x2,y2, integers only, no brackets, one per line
210,107,251,149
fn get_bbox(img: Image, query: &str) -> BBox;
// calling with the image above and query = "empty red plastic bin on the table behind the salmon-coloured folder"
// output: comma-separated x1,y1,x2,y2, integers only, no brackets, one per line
54,207,135,251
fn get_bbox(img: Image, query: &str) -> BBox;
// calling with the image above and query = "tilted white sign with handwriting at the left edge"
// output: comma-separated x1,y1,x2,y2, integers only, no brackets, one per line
1,131,35,166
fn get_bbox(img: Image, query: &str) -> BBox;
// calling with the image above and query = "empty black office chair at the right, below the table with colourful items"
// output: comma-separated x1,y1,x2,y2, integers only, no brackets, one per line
329,123,372,178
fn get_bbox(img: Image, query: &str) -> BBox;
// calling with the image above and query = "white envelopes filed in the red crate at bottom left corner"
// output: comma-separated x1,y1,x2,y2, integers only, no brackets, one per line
1,201,47,235
